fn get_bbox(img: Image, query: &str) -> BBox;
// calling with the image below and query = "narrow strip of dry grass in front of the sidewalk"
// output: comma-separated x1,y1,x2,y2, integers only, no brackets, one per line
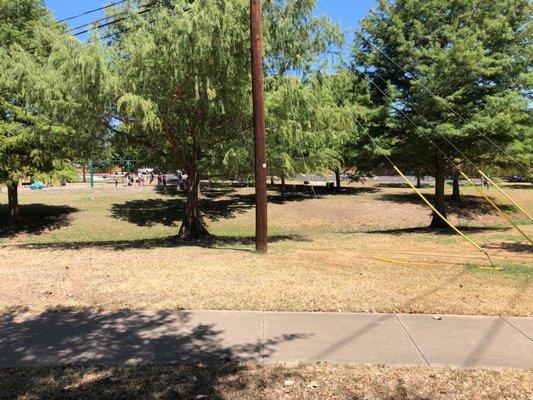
0,364,533,400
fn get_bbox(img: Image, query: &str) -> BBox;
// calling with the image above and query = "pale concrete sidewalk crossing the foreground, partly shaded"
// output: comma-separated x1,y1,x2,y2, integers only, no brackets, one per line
0,311,533,368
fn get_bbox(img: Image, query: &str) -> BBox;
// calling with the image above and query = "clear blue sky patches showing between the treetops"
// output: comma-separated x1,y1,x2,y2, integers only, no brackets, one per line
45,0,376,52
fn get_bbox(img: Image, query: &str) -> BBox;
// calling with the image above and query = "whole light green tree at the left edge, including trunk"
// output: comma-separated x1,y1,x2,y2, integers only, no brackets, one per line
0,0,113,219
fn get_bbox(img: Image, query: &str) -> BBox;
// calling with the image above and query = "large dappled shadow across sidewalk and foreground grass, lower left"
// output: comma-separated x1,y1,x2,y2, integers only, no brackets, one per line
0,311,308,399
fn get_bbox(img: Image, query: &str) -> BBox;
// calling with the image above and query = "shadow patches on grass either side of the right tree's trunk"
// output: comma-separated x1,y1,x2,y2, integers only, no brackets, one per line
379,193,518,218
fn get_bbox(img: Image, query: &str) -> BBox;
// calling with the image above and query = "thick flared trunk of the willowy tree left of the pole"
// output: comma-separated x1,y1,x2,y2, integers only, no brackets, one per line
178,166,209,239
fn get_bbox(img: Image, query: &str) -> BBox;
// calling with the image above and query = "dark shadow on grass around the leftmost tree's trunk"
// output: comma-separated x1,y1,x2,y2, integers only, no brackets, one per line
0,203,79,238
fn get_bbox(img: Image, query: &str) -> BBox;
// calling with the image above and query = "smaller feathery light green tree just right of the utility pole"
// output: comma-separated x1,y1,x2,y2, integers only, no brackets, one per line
266,76,353,195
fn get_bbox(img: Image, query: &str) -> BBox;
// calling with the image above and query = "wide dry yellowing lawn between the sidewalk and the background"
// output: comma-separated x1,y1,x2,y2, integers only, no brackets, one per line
0,183,533,316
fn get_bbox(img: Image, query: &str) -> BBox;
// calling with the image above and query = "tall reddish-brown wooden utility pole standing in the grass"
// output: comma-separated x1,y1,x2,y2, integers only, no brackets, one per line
250,0,268,253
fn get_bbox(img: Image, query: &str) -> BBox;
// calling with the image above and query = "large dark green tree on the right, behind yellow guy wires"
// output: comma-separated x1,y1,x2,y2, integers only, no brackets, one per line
353,0,531,227
